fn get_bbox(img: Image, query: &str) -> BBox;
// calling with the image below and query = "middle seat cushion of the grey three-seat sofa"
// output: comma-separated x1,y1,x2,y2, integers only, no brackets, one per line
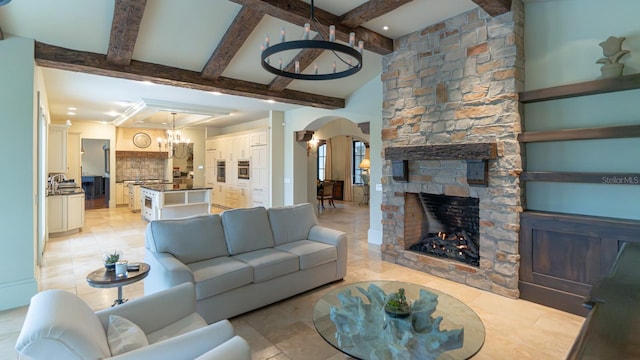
232,249,300,283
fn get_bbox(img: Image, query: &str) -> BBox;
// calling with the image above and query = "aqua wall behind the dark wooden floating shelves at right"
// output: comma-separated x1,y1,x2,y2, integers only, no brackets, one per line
525,0,640,219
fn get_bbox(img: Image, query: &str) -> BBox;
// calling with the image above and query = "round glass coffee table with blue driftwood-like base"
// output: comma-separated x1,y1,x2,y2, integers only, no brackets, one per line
313,281,485,360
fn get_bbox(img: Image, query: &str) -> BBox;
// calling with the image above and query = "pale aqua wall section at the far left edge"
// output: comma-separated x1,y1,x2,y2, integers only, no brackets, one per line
0,36,38,310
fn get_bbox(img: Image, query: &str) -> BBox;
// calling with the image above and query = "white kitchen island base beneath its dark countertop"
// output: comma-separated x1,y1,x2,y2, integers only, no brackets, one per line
141,184,211,221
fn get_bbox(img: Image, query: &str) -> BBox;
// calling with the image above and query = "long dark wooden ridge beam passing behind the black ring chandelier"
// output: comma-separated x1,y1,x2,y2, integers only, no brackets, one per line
231,0,393,55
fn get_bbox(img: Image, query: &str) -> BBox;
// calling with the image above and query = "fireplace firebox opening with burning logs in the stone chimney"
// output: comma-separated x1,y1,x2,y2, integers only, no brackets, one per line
405,193,480,266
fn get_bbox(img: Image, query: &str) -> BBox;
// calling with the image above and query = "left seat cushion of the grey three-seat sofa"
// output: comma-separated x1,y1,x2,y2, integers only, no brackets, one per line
187,257,253,300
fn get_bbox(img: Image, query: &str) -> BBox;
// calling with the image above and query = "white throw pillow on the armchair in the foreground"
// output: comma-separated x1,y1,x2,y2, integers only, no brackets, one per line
107,315,149,355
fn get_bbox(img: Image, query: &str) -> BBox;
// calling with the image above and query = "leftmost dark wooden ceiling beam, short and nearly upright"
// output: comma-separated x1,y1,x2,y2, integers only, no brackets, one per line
107,0,147,66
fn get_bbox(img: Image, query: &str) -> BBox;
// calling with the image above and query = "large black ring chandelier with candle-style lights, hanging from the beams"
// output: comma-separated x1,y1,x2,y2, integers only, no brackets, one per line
261,0,364,80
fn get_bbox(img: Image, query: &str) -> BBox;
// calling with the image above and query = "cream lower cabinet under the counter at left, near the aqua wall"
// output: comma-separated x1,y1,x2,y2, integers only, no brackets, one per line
47,193,84,234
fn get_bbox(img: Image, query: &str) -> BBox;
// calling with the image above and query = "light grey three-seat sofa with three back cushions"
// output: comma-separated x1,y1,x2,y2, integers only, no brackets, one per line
144,204,347,323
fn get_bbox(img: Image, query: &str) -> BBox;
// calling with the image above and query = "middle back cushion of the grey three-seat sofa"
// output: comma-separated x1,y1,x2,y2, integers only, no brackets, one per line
222,207,274,255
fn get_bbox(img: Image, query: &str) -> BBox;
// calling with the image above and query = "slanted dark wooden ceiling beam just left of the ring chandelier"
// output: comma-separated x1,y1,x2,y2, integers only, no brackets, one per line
202,6,264,80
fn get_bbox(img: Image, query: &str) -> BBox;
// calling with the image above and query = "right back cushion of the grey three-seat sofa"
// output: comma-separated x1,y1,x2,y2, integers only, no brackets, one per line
268,203,317,245
